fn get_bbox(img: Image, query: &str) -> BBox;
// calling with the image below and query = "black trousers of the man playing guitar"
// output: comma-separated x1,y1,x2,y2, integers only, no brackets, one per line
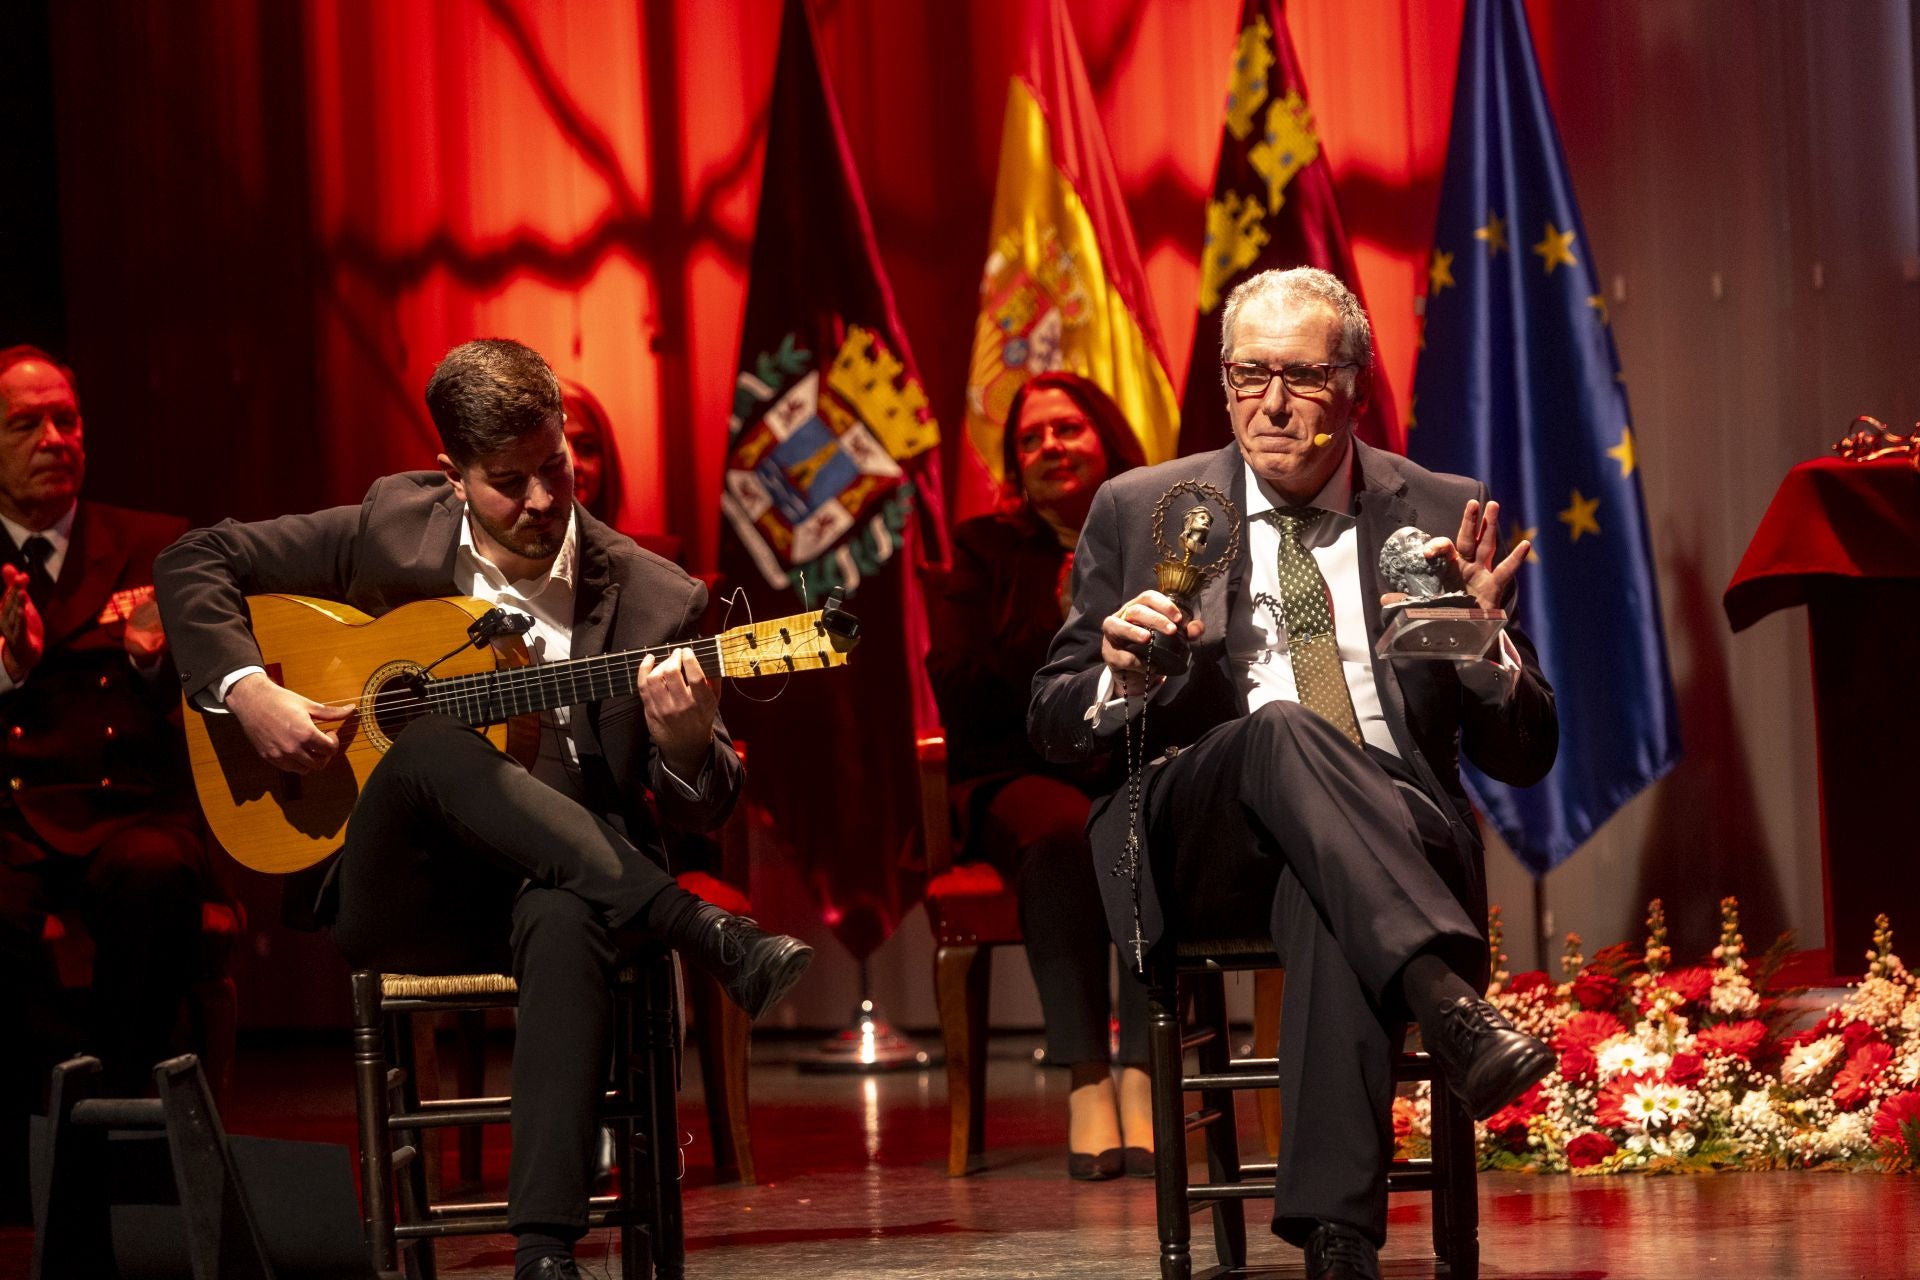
323,716,672,1228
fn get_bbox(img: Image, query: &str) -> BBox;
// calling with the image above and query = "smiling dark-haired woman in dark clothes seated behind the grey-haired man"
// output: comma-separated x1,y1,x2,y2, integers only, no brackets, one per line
927,372,1154,1180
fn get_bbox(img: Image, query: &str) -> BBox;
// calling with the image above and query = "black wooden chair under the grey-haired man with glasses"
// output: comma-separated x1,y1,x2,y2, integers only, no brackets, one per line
1146,940,1480,1280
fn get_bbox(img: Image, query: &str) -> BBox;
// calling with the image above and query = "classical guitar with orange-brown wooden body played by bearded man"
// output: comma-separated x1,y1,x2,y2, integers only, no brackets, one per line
184,595,860,873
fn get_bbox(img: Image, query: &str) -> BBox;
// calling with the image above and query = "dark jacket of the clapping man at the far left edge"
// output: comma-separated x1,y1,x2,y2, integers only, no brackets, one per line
0,501,192,862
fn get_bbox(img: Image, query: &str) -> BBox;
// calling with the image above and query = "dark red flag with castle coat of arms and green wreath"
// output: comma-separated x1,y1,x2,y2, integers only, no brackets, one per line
720,0,947,956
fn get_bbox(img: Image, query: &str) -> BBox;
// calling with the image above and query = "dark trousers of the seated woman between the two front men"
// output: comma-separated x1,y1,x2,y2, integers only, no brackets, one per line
981,773,1146,1067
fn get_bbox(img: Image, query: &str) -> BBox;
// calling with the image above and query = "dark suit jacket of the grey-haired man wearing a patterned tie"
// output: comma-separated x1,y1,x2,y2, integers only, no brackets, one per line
1027,441,1559,944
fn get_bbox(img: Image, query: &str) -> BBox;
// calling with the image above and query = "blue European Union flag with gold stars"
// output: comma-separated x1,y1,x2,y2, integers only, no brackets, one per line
1407,0,1680,875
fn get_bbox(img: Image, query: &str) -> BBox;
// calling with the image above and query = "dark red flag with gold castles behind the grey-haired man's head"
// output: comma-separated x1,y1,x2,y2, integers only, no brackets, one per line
1181,0,1405,453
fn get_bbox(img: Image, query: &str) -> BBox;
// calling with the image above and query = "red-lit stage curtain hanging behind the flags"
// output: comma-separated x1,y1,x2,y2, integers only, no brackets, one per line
56,0,1551,568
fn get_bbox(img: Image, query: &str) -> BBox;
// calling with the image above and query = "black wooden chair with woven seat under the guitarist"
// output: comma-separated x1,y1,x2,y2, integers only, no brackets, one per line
351,952,685,1280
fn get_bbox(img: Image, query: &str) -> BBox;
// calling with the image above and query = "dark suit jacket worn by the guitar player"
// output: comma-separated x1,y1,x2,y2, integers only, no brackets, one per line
156,472,741,886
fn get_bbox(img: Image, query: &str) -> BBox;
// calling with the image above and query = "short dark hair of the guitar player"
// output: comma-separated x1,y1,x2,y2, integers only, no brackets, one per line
426,338,561,466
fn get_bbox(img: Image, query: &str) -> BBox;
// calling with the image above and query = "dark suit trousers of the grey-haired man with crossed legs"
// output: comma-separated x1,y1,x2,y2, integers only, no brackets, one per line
1146,702,1486,1244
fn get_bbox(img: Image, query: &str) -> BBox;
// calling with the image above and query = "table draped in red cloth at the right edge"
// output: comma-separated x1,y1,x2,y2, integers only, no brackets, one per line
1724,459,1920,977
